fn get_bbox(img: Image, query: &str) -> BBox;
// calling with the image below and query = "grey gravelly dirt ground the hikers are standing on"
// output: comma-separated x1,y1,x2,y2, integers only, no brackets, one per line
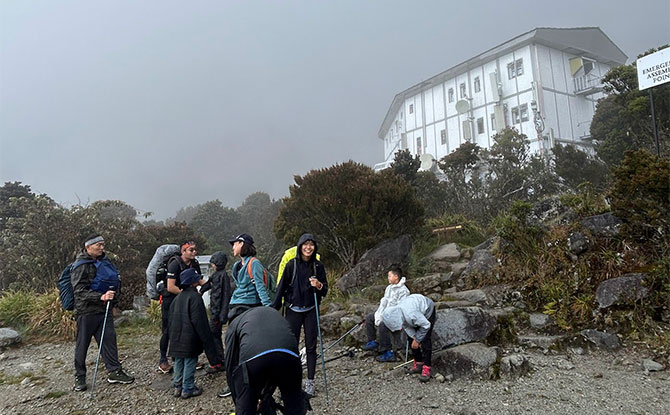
0,335,670,415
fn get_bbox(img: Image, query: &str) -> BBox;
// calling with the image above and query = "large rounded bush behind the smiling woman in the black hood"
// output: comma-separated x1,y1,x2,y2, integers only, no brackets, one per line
274,161,423,267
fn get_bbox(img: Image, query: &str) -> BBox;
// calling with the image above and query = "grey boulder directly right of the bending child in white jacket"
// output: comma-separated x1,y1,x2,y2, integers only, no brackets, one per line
433,307,497,350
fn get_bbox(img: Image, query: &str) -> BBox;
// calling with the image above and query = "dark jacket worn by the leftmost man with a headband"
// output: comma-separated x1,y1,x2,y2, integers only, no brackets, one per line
70,249,118,316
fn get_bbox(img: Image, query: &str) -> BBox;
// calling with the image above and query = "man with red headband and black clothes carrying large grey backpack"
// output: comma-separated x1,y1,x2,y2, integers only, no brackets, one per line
158,241,200,373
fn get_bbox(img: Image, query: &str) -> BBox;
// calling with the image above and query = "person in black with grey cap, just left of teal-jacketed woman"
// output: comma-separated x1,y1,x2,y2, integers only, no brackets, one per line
200,251,232,373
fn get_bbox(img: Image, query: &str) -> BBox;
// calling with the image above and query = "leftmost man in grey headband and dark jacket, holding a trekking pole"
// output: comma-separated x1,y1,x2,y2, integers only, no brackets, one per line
71,233,135,392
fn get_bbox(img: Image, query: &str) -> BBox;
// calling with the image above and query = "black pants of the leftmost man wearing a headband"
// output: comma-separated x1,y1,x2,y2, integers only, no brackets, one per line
74,312,121,376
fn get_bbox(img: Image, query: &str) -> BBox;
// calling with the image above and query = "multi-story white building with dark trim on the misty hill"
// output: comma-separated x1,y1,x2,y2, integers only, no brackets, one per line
375,27,627,169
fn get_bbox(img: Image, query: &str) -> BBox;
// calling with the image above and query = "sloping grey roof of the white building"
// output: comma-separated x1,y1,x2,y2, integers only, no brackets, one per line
377,27,628,139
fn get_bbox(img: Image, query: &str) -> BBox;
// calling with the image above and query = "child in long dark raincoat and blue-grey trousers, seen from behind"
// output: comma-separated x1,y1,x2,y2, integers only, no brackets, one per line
168,268,216,399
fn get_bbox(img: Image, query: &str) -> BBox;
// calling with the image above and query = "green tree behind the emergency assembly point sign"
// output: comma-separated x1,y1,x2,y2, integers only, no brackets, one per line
591,45,670,166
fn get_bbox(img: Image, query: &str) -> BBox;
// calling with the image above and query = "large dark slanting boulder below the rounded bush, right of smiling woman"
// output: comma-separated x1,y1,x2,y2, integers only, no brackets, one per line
337,235,412,292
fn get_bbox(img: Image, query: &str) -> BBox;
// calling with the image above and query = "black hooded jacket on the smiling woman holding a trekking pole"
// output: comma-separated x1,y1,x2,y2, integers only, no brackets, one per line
272,233,328,310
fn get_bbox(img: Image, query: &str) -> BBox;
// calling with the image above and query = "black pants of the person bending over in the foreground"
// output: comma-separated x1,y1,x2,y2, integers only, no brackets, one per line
230,352,307,415
